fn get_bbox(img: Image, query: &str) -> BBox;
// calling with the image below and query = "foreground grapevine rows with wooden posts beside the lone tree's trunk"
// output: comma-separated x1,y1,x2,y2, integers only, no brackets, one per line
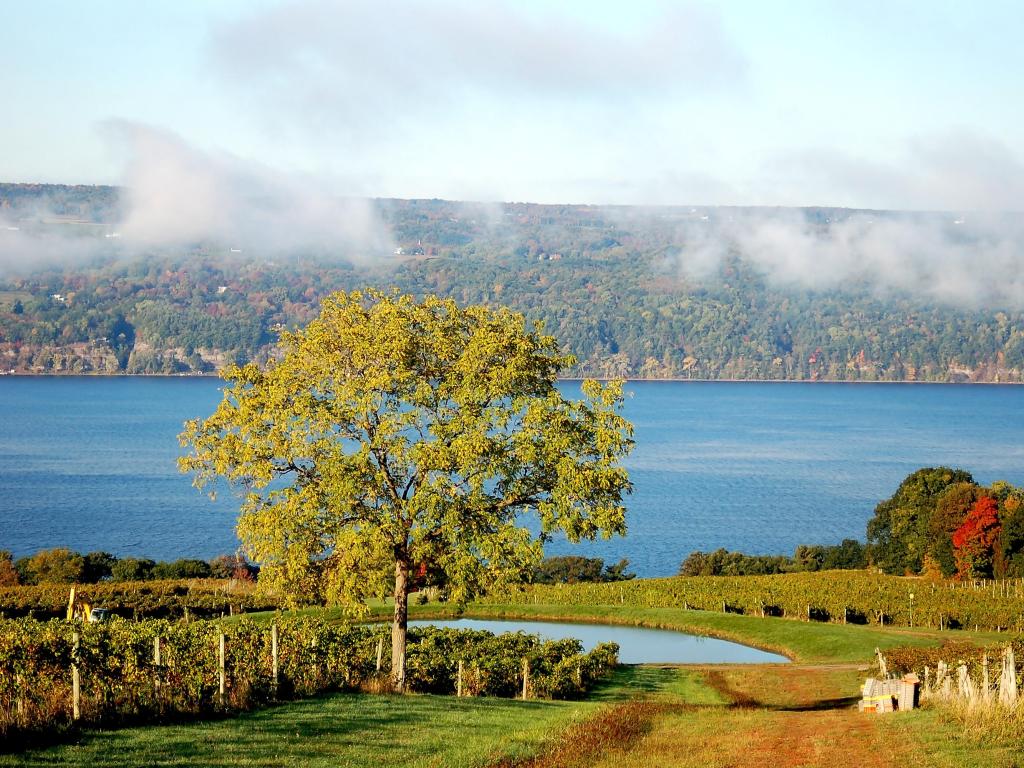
0,617,618,736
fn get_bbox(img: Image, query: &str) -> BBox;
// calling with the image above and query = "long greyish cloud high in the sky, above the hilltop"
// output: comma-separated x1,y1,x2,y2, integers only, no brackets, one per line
205,0,746,143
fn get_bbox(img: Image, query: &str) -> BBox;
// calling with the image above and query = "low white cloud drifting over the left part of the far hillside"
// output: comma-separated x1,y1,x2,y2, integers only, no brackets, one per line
0,121,393,272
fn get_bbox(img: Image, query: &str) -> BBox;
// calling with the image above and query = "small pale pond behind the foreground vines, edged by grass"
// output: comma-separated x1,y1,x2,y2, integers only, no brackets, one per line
409,618,790,664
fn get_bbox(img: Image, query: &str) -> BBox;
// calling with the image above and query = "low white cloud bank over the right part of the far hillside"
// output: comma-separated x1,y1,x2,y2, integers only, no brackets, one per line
678,209,1024,309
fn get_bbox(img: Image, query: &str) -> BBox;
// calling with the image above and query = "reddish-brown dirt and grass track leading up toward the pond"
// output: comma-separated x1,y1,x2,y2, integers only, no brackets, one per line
499,666,920,768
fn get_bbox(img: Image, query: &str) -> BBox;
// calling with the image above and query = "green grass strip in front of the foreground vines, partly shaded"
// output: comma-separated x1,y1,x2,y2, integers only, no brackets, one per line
0,693,600,768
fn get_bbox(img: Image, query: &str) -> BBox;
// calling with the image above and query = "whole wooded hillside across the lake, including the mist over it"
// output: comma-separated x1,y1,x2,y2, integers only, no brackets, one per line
0,178,1024,381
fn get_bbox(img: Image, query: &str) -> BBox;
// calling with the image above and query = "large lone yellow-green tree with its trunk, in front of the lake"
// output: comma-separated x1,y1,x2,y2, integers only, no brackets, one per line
180,291,633,689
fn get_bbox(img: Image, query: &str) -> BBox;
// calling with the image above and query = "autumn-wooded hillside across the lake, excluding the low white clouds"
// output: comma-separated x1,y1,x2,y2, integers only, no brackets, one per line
0,184,1024,382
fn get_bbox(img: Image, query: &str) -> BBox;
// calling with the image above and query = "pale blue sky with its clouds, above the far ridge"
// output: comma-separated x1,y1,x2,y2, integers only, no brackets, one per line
0,0,1024,211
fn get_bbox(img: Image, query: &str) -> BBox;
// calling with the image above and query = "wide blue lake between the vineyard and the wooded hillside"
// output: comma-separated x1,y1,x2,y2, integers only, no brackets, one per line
0,377,1024,577
